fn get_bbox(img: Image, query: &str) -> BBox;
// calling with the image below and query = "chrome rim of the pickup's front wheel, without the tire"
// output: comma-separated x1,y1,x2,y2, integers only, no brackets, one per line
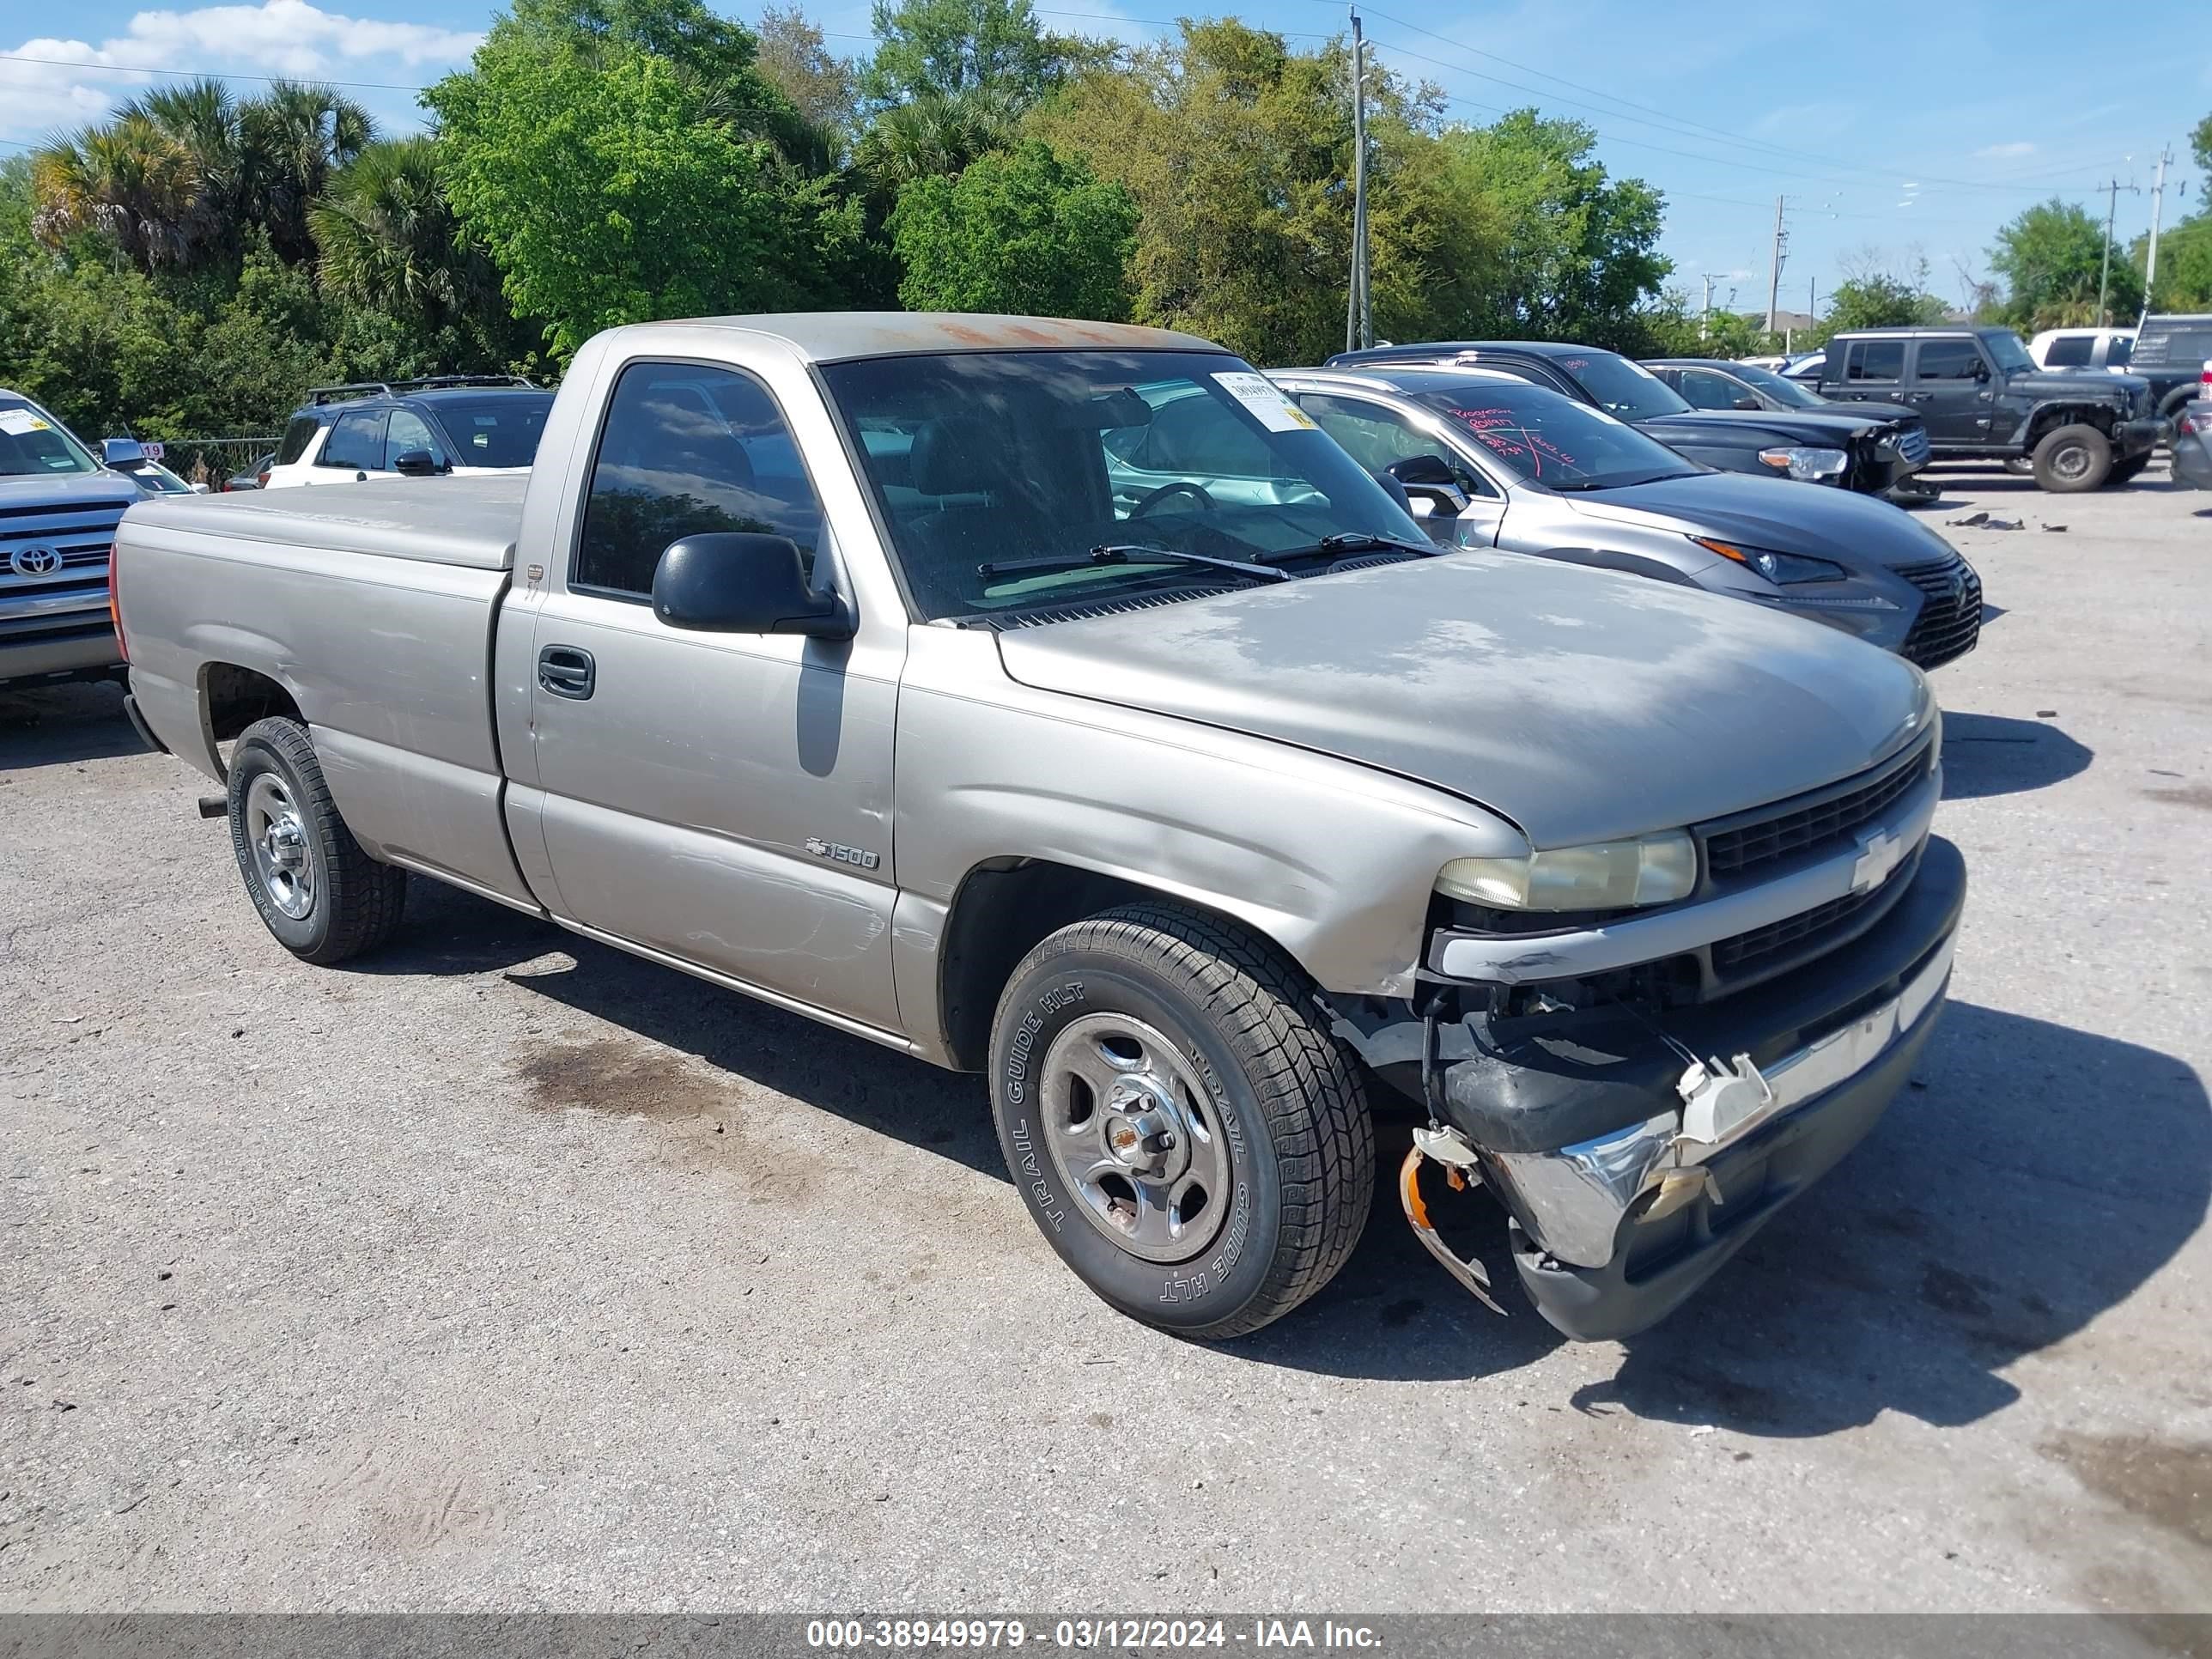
1042,1013,1230,1261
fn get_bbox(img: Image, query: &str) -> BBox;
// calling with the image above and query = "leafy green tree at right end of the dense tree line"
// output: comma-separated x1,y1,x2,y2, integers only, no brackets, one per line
1443,108,1672,349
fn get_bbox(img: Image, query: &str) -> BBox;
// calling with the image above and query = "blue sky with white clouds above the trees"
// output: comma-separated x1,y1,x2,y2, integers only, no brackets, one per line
0,0,2212,325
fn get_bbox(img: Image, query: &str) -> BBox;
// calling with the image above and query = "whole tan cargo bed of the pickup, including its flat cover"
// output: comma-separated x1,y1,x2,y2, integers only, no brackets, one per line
115,477,535,909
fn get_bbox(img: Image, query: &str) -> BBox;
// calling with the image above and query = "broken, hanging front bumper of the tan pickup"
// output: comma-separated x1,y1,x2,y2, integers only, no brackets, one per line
1340,838,1966,1340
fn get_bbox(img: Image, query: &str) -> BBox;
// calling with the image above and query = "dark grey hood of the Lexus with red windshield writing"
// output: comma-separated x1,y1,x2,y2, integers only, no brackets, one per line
1559,473,1951,568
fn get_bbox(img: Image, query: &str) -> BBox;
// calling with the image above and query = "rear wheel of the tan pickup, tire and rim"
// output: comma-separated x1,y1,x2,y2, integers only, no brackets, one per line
228,719,407,964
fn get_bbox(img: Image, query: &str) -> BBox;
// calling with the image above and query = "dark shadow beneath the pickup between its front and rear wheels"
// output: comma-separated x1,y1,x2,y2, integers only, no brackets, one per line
374,880,1006,1182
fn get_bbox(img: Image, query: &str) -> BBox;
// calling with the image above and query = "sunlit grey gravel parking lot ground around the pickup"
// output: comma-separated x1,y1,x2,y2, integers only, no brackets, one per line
0,462,2212,1613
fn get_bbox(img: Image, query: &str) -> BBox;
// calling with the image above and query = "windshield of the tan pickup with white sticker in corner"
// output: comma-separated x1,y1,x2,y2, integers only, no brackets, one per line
823,352,1427,619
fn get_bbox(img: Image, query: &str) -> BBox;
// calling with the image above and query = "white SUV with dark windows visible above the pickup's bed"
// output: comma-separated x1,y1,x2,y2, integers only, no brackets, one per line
261,374,553,489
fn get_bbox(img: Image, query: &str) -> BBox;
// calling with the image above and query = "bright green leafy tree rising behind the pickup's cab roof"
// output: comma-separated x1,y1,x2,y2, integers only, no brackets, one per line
425,17,860,356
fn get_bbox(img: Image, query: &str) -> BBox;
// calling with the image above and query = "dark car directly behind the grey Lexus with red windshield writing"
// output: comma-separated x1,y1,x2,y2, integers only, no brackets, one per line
1328,341,1937,493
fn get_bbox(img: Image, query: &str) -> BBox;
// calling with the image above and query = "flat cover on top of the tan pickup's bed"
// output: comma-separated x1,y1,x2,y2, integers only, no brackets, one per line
131,473,529,571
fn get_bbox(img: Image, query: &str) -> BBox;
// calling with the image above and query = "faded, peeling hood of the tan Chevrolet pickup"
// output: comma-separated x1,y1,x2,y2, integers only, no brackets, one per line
998,555,1933,848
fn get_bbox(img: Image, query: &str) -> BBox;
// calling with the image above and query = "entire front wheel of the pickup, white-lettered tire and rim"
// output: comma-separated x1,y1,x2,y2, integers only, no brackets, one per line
991,902,1376,1340
